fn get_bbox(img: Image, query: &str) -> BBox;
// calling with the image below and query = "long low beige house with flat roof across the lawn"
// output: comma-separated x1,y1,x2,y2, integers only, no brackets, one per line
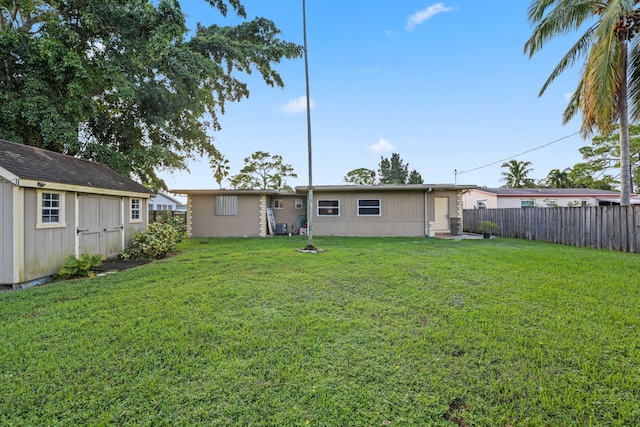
171,184,475,237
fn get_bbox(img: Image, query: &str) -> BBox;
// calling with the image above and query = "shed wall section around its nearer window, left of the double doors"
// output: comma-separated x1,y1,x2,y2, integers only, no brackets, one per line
23,189,76,281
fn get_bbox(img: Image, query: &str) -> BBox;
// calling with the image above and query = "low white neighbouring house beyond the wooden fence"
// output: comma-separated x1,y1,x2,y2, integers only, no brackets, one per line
462,187,640,209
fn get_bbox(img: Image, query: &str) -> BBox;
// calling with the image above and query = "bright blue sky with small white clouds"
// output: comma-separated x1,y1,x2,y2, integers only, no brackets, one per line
161,0,589,195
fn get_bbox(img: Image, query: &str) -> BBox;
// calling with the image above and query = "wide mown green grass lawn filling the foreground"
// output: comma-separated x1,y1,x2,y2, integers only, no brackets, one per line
0,237,640,427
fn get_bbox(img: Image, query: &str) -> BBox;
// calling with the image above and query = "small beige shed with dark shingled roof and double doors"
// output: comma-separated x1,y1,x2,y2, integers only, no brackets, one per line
0,140,151,286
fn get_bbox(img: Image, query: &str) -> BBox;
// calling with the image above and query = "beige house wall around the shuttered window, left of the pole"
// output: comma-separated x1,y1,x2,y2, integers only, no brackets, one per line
189,195,261,237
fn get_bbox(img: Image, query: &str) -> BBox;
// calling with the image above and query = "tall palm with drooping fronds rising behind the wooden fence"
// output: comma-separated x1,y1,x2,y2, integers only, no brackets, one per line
524,0,640,206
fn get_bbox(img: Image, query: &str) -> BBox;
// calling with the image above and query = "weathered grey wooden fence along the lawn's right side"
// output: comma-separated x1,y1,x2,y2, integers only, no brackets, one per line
463,206,640,253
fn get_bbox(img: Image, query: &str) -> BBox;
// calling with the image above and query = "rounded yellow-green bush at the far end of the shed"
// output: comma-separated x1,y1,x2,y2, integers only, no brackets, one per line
120,222,180,260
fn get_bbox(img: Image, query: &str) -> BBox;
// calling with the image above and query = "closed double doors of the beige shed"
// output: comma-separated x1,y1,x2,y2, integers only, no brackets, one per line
76,195,124,258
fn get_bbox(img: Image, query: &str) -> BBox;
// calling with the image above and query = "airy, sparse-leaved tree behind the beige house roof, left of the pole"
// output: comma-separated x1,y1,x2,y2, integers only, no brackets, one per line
231,151,298,190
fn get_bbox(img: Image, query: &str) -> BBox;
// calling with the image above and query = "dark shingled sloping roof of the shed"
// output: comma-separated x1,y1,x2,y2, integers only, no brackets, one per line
0,139,152,194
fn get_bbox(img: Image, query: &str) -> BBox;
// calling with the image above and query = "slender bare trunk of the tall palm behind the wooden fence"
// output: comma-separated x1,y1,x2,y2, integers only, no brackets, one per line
618,41,631,206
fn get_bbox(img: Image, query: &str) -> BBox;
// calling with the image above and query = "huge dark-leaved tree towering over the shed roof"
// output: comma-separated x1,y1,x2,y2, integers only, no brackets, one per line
0,0,301,188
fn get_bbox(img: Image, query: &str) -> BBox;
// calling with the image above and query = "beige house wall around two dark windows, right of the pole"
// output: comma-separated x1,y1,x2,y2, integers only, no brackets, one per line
313,191,425,237
